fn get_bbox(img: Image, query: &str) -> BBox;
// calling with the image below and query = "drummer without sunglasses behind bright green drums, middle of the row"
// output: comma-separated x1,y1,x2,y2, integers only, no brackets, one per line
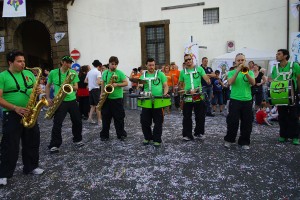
140,58,169,147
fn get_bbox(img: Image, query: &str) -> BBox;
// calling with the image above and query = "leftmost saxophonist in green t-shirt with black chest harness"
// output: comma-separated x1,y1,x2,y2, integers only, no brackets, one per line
0,51,44,186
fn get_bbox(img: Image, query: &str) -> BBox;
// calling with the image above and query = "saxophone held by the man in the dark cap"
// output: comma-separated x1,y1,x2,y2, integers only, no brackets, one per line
45,72,76,119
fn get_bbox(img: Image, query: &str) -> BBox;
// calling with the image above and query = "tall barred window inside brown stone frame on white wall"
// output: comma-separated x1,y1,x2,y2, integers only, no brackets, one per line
146,26,166,65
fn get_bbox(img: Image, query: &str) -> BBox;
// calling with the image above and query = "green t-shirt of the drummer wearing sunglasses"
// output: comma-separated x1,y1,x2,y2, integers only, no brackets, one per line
179,66,206,91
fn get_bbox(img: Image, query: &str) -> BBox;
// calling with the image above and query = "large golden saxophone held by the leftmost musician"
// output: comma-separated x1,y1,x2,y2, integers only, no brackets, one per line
21,67,48,128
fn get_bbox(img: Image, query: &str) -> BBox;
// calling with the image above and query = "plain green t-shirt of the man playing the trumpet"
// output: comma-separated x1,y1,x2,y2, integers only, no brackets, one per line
228,69,255,101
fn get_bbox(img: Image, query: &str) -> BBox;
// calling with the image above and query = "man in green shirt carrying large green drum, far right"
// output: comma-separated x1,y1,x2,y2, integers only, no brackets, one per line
272,49,300,145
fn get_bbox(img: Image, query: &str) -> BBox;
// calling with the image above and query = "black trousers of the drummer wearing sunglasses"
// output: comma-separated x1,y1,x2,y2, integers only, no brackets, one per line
182,101,205,139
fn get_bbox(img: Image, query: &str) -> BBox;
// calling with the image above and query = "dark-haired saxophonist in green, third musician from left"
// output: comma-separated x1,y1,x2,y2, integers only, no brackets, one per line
100,56,128,141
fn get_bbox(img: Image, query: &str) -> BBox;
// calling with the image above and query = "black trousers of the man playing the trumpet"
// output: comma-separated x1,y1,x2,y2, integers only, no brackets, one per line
224,99,253,145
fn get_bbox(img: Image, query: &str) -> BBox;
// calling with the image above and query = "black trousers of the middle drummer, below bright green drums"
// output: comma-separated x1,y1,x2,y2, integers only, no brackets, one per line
141,108,164,143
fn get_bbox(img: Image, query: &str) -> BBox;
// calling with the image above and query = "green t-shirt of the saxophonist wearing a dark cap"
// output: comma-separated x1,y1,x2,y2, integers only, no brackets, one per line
48,68,79,101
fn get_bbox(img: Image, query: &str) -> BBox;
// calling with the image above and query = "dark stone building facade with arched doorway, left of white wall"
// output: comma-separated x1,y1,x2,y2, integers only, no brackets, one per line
0,0,74,71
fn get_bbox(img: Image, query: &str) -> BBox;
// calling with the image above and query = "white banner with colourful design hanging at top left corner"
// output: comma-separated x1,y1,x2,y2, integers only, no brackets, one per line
2,0,26,17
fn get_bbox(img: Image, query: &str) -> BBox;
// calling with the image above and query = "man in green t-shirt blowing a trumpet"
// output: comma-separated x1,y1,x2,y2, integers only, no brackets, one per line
224,53,255,150
